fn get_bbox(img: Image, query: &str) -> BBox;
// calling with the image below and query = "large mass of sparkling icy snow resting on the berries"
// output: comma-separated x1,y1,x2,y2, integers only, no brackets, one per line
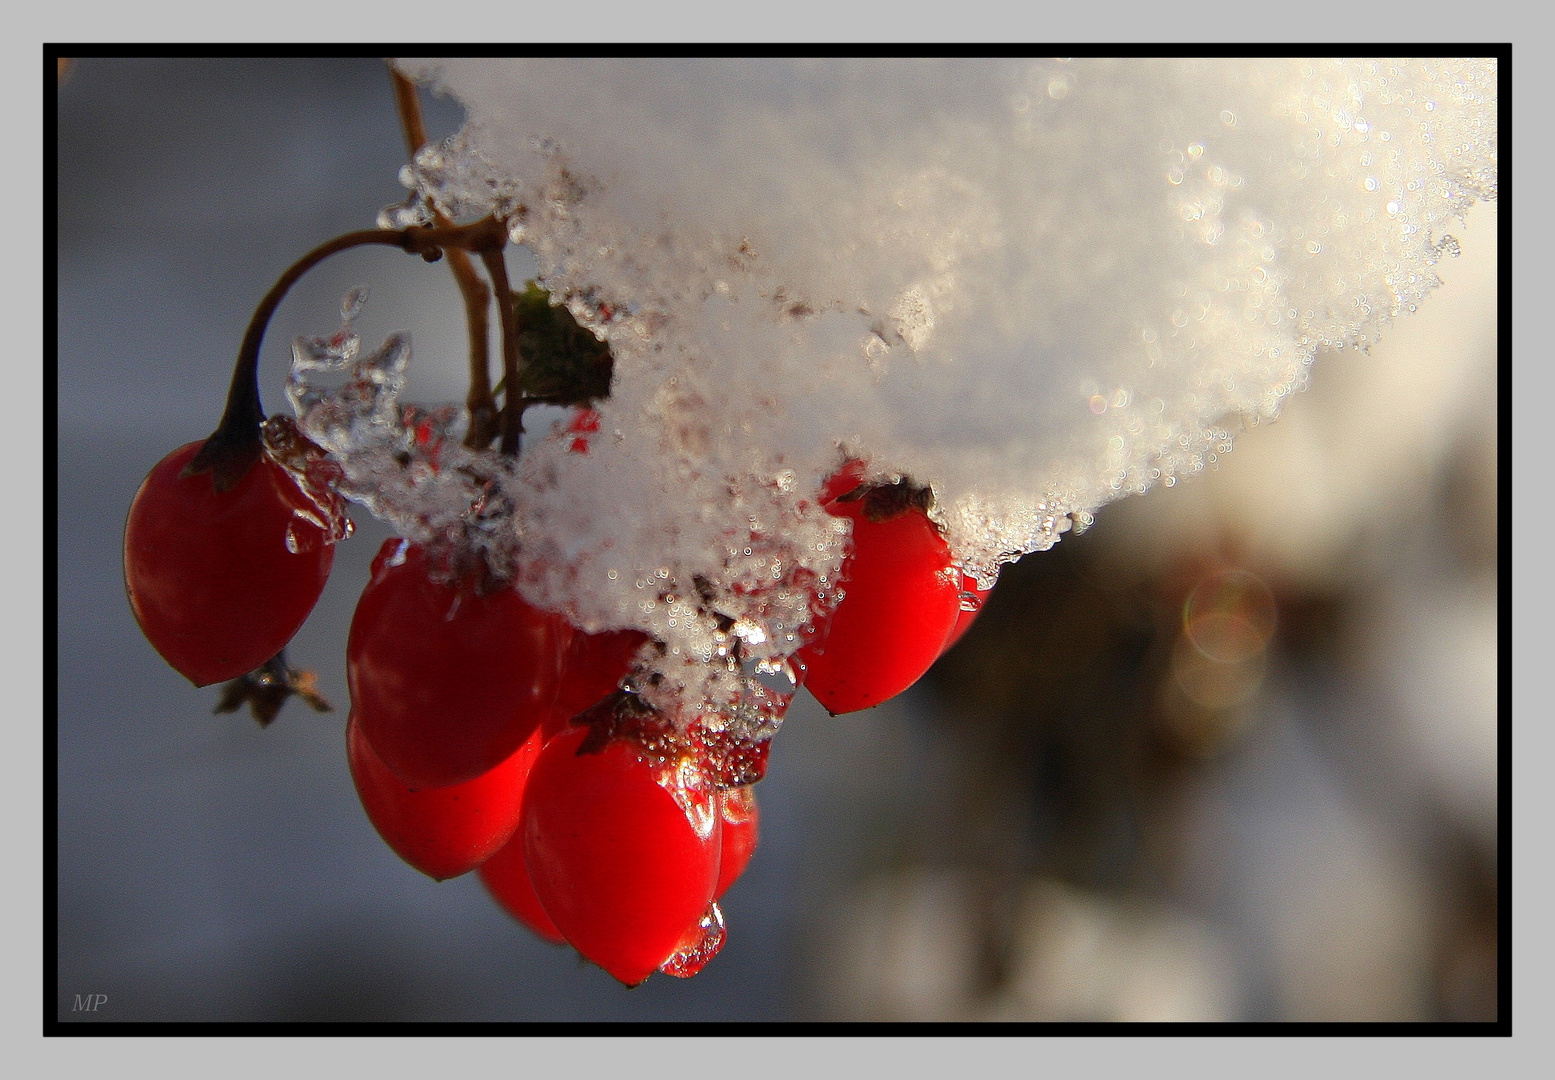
283,59,1497,736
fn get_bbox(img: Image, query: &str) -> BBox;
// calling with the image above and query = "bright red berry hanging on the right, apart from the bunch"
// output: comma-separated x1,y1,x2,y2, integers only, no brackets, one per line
795,485,961,716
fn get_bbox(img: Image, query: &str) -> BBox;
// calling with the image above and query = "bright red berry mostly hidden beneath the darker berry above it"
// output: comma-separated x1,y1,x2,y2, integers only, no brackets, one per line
345,712,540,881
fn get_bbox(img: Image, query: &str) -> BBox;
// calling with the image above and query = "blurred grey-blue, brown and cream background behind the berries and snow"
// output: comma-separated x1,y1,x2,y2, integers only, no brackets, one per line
56,59,1499,1023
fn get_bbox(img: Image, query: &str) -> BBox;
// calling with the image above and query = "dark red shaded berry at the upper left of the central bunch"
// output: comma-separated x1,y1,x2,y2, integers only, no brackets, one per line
345,539,571,788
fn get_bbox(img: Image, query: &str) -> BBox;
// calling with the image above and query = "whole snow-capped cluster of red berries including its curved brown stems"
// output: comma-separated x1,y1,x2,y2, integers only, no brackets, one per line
115,73,986,985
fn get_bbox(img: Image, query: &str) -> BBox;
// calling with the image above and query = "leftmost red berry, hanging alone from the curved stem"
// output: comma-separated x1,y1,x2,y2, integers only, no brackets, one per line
124,441,334,687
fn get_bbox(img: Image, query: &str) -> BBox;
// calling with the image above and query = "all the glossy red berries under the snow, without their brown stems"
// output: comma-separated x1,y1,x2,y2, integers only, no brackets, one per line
124,415,986,985
